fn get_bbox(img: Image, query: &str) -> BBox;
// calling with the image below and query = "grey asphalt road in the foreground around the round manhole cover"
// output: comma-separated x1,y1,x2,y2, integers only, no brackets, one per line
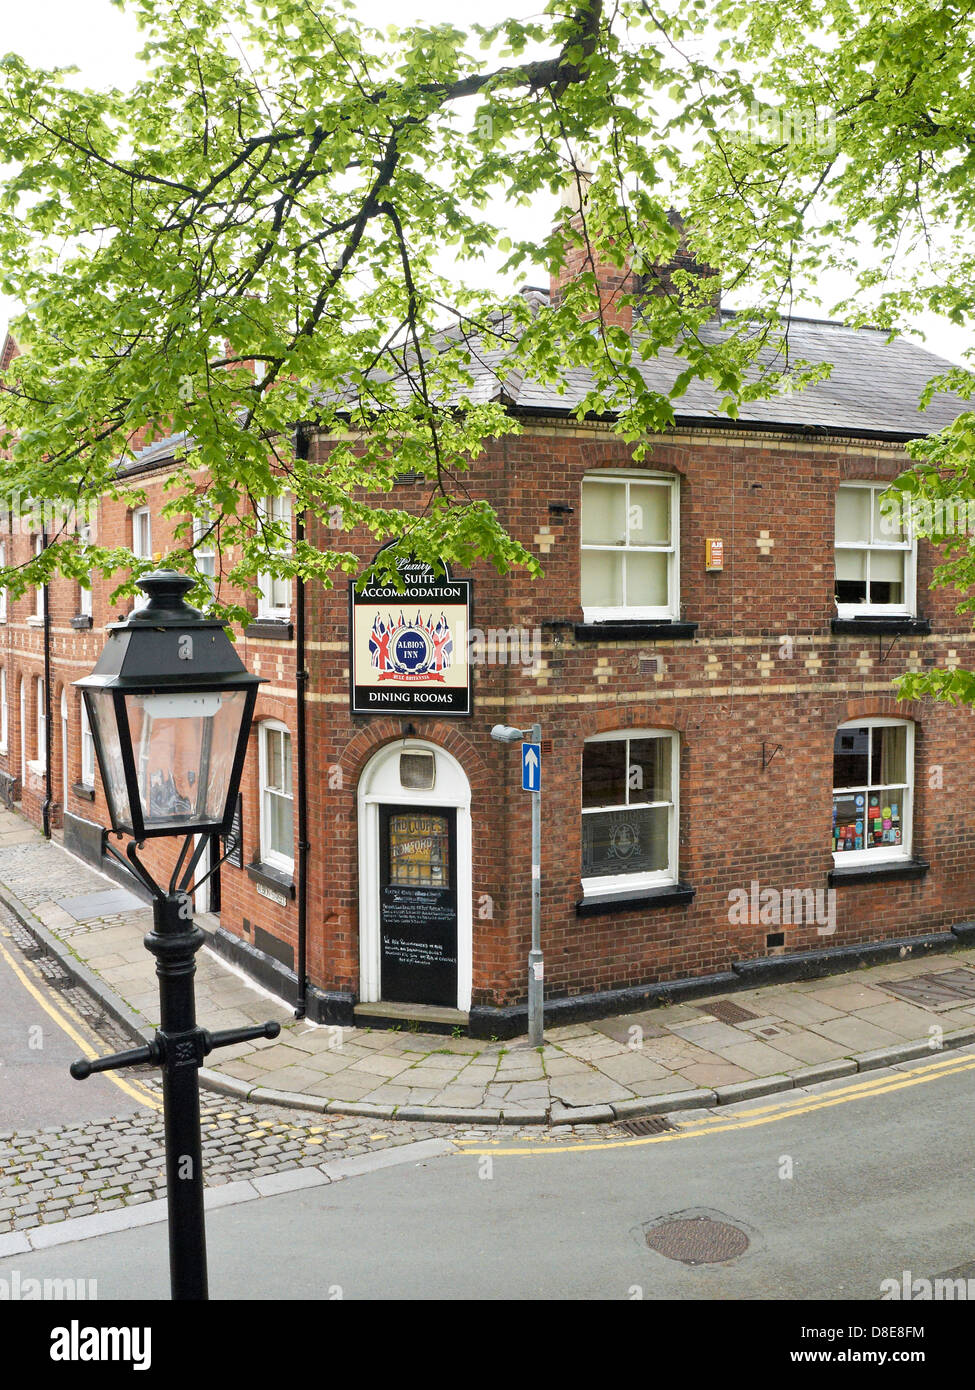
7,1052,975,1311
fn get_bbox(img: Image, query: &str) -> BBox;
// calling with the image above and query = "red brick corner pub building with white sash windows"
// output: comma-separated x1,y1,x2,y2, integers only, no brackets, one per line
0,252,975,1036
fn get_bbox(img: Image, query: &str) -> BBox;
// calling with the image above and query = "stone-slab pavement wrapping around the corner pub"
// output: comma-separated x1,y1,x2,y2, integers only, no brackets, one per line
0,812,975,1126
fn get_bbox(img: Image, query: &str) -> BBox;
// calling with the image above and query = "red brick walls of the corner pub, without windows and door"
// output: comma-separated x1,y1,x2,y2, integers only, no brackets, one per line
0,421,975,1004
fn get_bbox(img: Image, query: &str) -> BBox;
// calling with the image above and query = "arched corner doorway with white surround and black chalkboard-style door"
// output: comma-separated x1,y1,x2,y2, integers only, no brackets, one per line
359,738,473,1012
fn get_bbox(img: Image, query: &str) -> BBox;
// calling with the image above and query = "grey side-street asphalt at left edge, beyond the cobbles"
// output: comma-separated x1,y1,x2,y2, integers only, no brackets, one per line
0,919,139,1130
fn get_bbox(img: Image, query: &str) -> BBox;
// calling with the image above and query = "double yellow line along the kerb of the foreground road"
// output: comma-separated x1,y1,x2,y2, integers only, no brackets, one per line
455,1052,975,1158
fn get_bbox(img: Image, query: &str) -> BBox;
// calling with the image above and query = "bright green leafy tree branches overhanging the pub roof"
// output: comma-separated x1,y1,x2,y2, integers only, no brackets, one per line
0,0,975,678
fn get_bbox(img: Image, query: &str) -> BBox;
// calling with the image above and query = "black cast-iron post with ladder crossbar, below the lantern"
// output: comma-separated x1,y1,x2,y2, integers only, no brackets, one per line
71,872,281,1300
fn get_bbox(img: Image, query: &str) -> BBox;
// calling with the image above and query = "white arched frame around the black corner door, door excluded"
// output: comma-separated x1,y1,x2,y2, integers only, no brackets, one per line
357,738,473,1013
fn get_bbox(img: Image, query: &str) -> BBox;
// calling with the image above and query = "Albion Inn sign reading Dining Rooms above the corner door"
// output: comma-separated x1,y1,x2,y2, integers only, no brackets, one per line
349,559,472,714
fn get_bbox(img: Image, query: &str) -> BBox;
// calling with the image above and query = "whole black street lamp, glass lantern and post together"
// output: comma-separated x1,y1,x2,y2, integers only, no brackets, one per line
71,570,281,1300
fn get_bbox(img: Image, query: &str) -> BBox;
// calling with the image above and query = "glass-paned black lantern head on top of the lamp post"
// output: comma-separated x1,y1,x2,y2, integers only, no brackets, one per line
75,570,260,842
